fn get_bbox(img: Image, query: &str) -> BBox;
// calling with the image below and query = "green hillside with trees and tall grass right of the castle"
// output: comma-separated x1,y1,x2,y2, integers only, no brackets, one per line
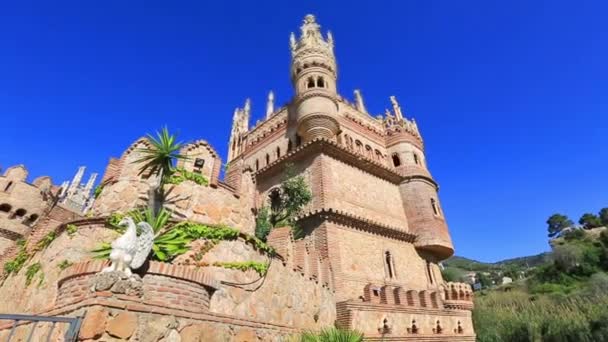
466,208,608,342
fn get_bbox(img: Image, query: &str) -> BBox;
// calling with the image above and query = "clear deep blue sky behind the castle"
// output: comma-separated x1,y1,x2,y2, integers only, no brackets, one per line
0,0,608,261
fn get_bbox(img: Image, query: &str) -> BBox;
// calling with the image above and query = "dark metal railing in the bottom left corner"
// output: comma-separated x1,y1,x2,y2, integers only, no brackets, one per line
0,314,82,342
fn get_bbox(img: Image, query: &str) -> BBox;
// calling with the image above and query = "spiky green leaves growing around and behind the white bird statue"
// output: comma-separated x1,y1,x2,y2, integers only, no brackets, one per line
92,208,192,261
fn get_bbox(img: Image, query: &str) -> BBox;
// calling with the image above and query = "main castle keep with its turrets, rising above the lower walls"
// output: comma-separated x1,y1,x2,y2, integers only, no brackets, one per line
227,15,453,299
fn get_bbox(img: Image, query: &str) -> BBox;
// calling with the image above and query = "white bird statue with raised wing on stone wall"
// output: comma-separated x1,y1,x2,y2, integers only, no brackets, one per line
102,216,154,277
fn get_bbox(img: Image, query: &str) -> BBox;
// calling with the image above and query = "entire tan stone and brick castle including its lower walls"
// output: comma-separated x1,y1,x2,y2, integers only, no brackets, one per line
0,15,475,341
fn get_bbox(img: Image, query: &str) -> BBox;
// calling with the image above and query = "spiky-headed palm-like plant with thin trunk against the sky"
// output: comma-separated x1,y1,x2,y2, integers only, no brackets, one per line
134,127,187,215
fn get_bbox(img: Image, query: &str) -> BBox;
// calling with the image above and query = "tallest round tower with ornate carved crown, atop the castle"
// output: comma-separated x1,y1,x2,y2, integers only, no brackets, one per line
290,14,340,142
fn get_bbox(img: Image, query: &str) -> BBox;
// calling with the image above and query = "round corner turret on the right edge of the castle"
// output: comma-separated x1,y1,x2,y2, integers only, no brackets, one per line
385,101,454,261
